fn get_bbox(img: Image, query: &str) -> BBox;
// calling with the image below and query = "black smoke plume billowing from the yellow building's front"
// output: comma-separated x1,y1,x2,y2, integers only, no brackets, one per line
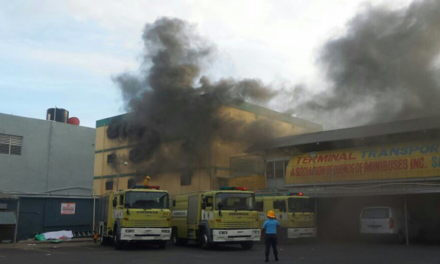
107,18,282,175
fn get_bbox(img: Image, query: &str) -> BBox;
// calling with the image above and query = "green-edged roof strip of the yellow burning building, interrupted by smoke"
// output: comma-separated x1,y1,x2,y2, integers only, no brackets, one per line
96,102,322,131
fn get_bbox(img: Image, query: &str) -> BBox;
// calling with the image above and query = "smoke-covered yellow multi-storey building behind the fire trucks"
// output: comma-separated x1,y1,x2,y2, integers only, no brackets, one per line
94,102,322,194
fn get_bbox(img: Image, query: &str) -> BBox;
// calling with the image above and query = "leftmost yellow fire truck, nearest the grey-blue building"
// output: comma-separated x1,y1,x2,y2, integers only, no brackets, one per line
98,186,171,249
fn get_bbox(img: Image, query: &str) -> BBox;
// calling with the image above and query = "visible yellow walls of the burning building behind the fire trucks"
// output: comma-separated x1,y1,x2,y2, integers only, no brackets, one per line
94,103,322,194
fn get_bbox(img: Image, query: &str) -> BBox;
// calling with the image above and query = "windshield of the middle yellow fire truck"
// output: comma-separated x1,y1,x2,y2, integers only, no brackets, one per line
215,193,255,210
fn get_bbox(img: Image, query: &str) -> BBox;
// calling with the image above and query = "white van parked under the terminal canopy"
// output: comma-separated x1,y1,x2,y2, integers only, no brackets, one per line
360,207,421,241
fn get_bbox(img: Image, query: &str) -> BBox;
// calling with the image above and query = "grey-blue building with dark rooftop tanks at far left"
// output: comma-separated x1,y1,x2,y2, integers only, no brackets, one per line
0,109,95,241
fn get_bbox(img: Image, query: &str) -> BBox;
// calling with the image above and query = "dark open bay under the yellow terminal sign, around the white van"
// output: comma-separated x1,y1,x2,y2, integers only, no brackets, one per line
301,183,440,245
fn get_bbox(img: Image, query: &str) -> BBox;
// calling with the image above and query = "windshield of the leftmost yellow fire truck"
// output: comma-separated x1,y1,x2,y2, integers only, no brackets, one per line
125,192,168,209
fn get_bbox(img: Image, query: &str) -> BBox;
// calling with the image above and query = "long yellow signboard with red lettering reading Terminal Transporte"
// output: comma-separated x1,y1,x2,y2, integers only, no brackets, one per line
285,142,440,185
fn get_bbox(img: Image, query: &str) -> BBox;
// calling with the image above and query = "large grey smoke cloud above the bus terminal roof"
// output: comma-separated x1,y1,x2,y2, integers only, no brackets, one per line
289,0,440,128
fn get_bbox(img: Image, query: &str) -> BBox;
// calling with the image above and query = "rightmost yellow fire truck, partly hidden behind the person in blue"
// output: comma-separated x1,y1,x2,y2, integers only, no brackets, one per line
256,193,317,239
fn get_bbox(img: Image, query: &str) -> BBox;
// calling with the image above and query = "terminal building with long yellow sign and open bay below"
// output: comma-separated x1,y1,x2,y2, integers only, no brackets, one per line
248,116,440,240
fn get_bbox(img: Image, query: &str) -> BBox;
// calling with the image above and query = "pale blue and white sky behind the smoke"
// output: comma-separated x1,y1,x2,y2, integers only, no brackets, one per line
0,0,410,127
